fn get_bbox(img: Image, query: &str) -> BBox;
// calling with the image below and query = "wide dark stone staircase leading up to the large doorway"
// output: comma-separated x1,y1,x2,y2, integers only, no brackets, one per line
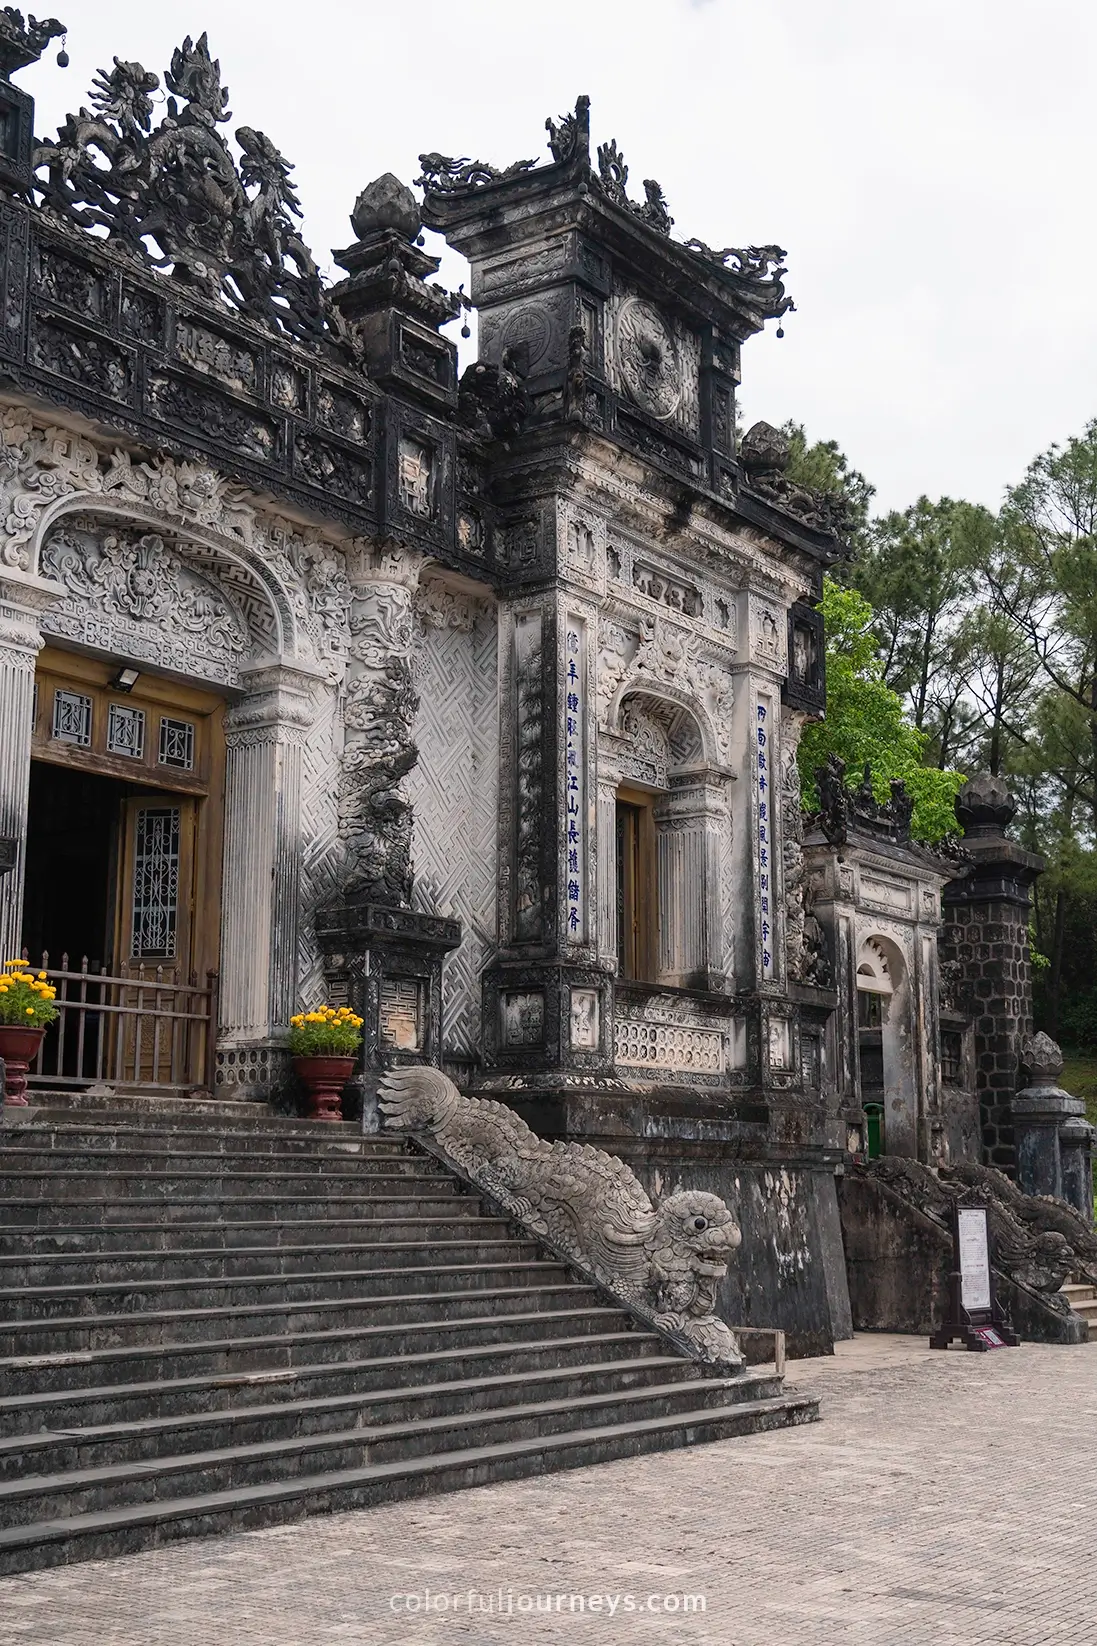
0,1100,819,1575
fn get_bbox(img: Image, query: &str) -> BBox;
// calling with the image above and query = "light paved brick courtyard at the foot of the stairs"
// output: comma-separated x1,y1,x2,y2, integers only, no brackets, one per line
0,1337,1097,1646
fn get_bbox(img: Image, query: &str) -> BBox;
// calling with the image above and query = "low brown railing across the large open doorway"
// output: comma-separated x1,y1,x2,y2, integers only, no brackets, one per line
23,950,217,1091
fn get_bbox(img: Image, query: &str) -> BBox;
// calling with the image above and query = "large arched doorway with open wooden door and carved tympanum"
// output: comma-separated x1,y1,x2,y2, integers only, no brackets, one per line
10,495,311,1090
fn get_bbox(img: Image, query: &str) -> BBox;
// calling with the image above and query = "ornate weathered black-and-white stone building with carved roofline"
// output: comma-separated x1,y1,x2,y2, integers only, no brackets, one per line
0,29,1073,1351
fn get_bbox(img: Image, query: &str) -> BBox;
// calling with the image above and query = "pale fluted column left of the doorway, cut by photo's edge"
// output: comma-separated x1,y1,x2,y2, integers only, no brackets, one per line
0,571,63,961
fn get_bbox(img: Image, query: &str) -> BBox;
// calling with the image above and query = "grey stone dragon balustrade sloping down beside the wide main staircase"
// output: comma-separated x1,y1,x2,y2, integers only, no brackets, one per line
380,1068,743,1366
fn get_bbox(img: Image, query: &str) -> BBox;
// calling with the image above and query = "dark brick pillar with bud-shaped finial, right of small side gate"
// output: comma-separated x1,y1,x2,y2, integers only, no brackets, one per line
939,775,1043,1172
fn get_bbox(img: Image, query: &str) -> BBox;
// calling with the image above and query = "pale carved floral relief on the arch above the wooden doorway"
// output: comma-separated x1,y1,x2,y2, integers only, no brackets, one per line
0,407,354,667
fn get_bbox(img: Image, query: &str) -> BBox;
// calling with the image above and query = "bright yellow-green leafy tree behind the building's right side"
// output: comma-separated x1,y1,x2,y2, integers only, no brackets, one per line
799,578,964,841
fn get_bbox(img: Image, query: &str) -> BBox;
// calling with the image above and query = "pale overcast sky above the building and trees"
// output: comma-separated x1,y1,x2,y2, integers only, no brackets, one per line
20,0,1097,507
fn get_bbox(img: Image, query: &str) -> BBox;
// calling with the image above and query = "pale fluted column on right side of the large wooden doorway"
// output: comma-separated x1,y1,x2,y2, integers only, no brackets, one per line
219,663,315,1060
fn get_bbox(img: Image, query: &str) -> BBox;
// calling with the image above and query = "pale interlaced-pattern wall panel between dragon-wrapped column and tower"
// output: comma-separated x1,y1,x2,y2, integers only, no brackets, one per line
405,584,499,1060
